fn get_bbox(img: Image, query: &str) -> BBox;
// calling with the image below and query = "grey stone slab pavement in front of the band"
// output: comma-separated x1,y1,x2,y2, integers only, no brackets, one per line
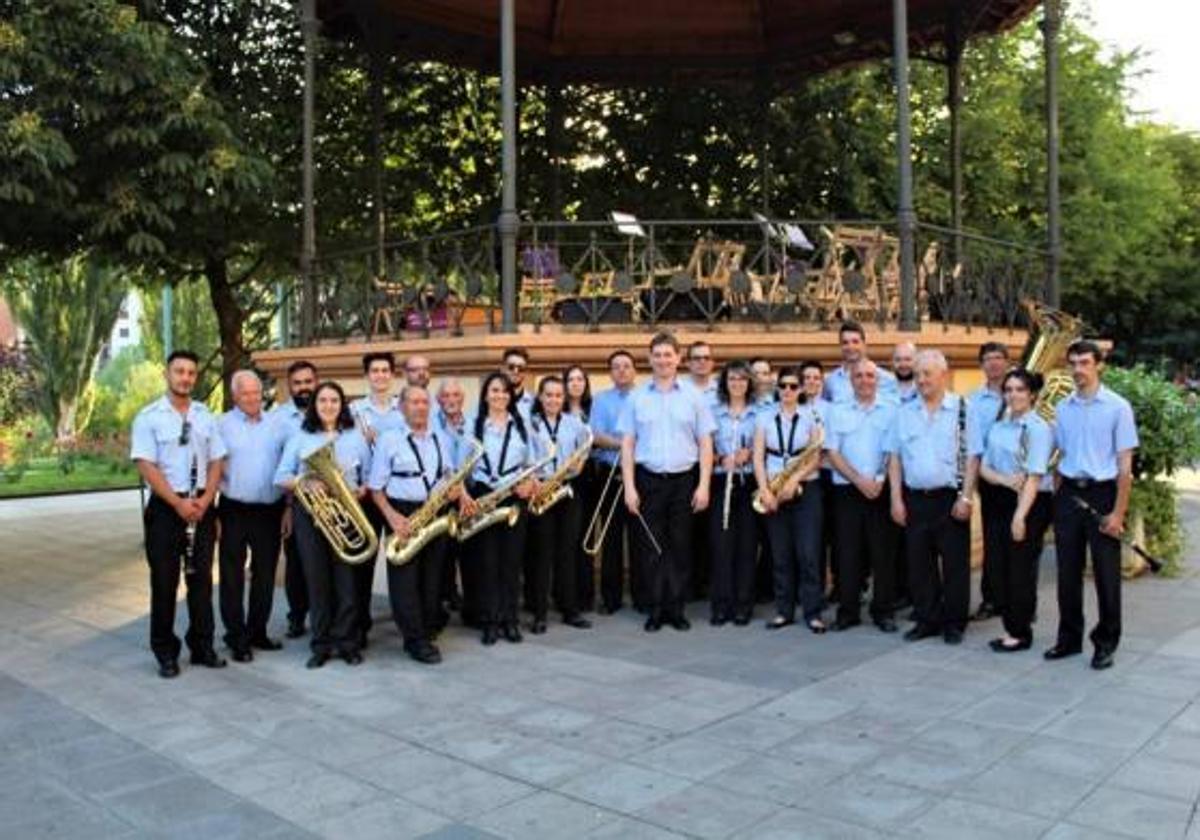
0,475,1200,840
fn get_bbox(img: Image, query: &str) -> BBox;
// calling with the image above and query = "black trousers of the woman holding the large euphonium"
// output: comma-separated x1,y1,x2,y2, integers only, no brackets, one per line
292,502,359,654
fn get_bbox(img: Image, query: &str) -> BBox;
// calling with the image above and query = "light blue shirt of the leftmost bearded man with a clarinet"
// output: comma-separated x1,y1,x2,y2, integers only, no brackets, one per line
130,395,226,494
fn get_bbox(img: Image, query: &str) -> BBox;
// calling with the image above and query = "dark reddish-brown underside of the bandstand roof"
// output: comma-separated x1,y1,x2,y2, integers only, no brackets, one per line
318,0,1040,84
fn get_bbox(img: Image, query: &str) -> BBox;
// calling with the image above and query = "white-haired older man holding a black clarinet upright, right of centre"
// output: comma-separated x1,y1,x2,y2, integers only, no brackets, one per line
888,350,976,644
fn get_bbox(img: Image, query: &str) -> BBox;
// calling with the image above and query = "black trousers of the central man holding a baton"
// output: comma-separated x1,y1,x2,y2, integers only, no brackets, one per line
631,467,700,620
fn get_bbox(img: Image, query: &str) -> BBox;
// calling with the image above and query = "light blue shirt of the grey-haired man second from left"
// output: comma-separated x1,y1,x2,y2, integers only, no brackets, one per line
217,408,288,504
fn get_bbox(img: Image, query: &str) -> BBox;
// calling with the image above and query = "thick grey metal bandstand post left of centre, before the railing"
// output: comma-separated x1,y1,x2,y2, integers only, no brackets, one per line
497,0,520,332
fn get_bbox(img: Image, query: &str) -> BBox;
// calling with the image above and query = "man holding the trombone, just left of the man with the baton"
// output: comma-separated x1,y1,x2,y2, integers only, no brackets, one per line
586,350,649,616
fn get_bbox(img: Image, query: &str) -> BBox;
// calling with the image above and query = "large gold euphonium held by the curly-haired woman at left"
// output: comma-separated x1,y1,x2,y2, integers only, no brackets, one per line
293,440,379,565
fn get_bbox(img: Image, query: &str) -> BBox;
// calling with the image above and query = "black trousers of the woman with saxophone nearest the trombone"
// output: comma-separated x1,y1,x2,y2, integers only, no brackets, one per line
526,496,583,622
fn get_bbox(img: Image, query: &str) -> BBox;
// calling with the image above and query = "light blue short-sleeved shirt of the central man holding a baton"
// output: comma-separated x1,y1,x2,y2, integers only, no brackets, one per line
617,378,716,473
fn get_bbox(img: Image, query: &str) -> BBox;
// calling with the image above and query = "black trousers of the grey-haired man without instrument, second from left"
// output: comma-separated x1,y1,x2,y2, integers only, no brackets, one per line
217,496,283,649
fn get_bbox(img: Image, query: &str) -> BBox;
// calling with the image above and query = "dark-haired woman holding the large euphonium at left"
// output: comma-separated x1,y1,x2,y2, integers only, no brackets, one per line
275,382,371,668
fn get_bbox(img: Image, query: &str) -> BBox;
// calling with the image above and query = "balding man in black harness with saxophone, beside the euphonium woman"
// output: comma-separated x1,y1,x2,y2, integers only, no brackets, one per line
367,385,455,665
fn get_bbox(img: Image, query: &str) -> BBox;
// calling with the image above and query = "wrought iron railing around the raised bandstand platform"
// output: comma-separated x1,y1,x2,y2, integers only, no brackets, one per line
276,220,1045,343
